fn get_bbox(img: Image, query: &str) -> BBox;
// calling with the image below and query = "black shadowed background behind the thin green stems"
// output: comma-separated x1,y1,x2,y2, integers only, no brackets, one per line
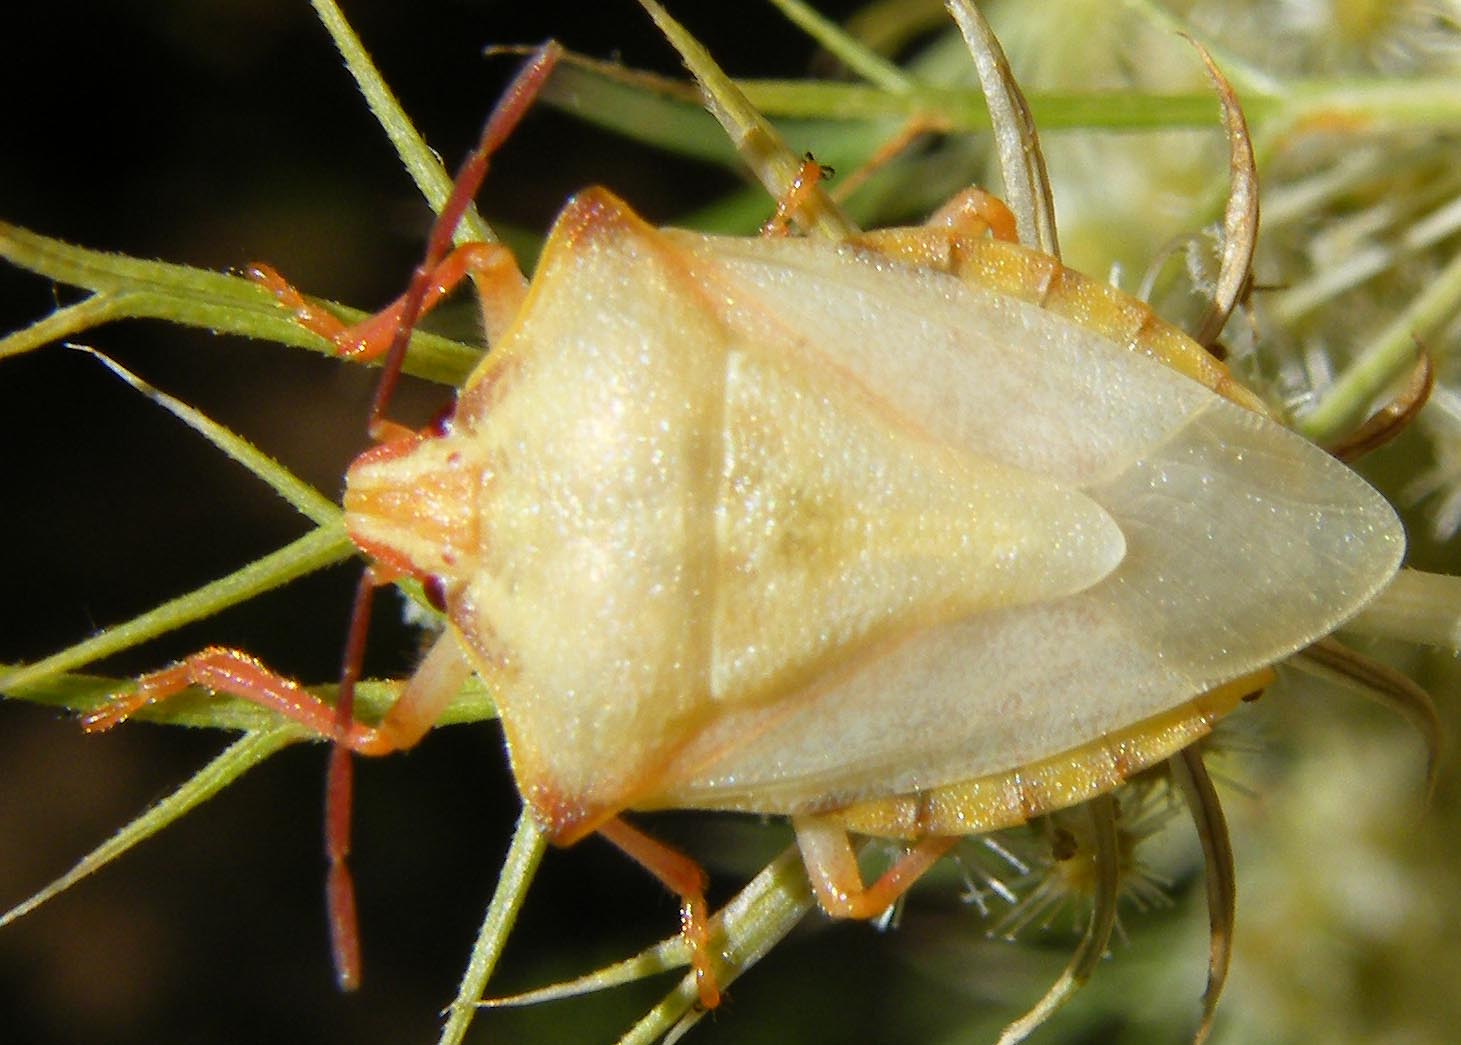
0,0,981,1042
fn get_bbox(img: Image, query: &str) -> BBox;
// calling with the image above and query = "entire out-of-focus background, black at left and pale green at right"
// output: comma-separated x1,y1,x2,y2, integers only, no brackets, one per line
0,0,1461,1042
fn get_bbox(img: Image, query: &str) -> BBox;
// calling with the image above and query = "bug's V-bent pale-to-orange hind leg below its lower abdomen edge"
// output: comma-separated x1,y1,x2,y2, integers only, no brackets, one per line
792,817,958,918
